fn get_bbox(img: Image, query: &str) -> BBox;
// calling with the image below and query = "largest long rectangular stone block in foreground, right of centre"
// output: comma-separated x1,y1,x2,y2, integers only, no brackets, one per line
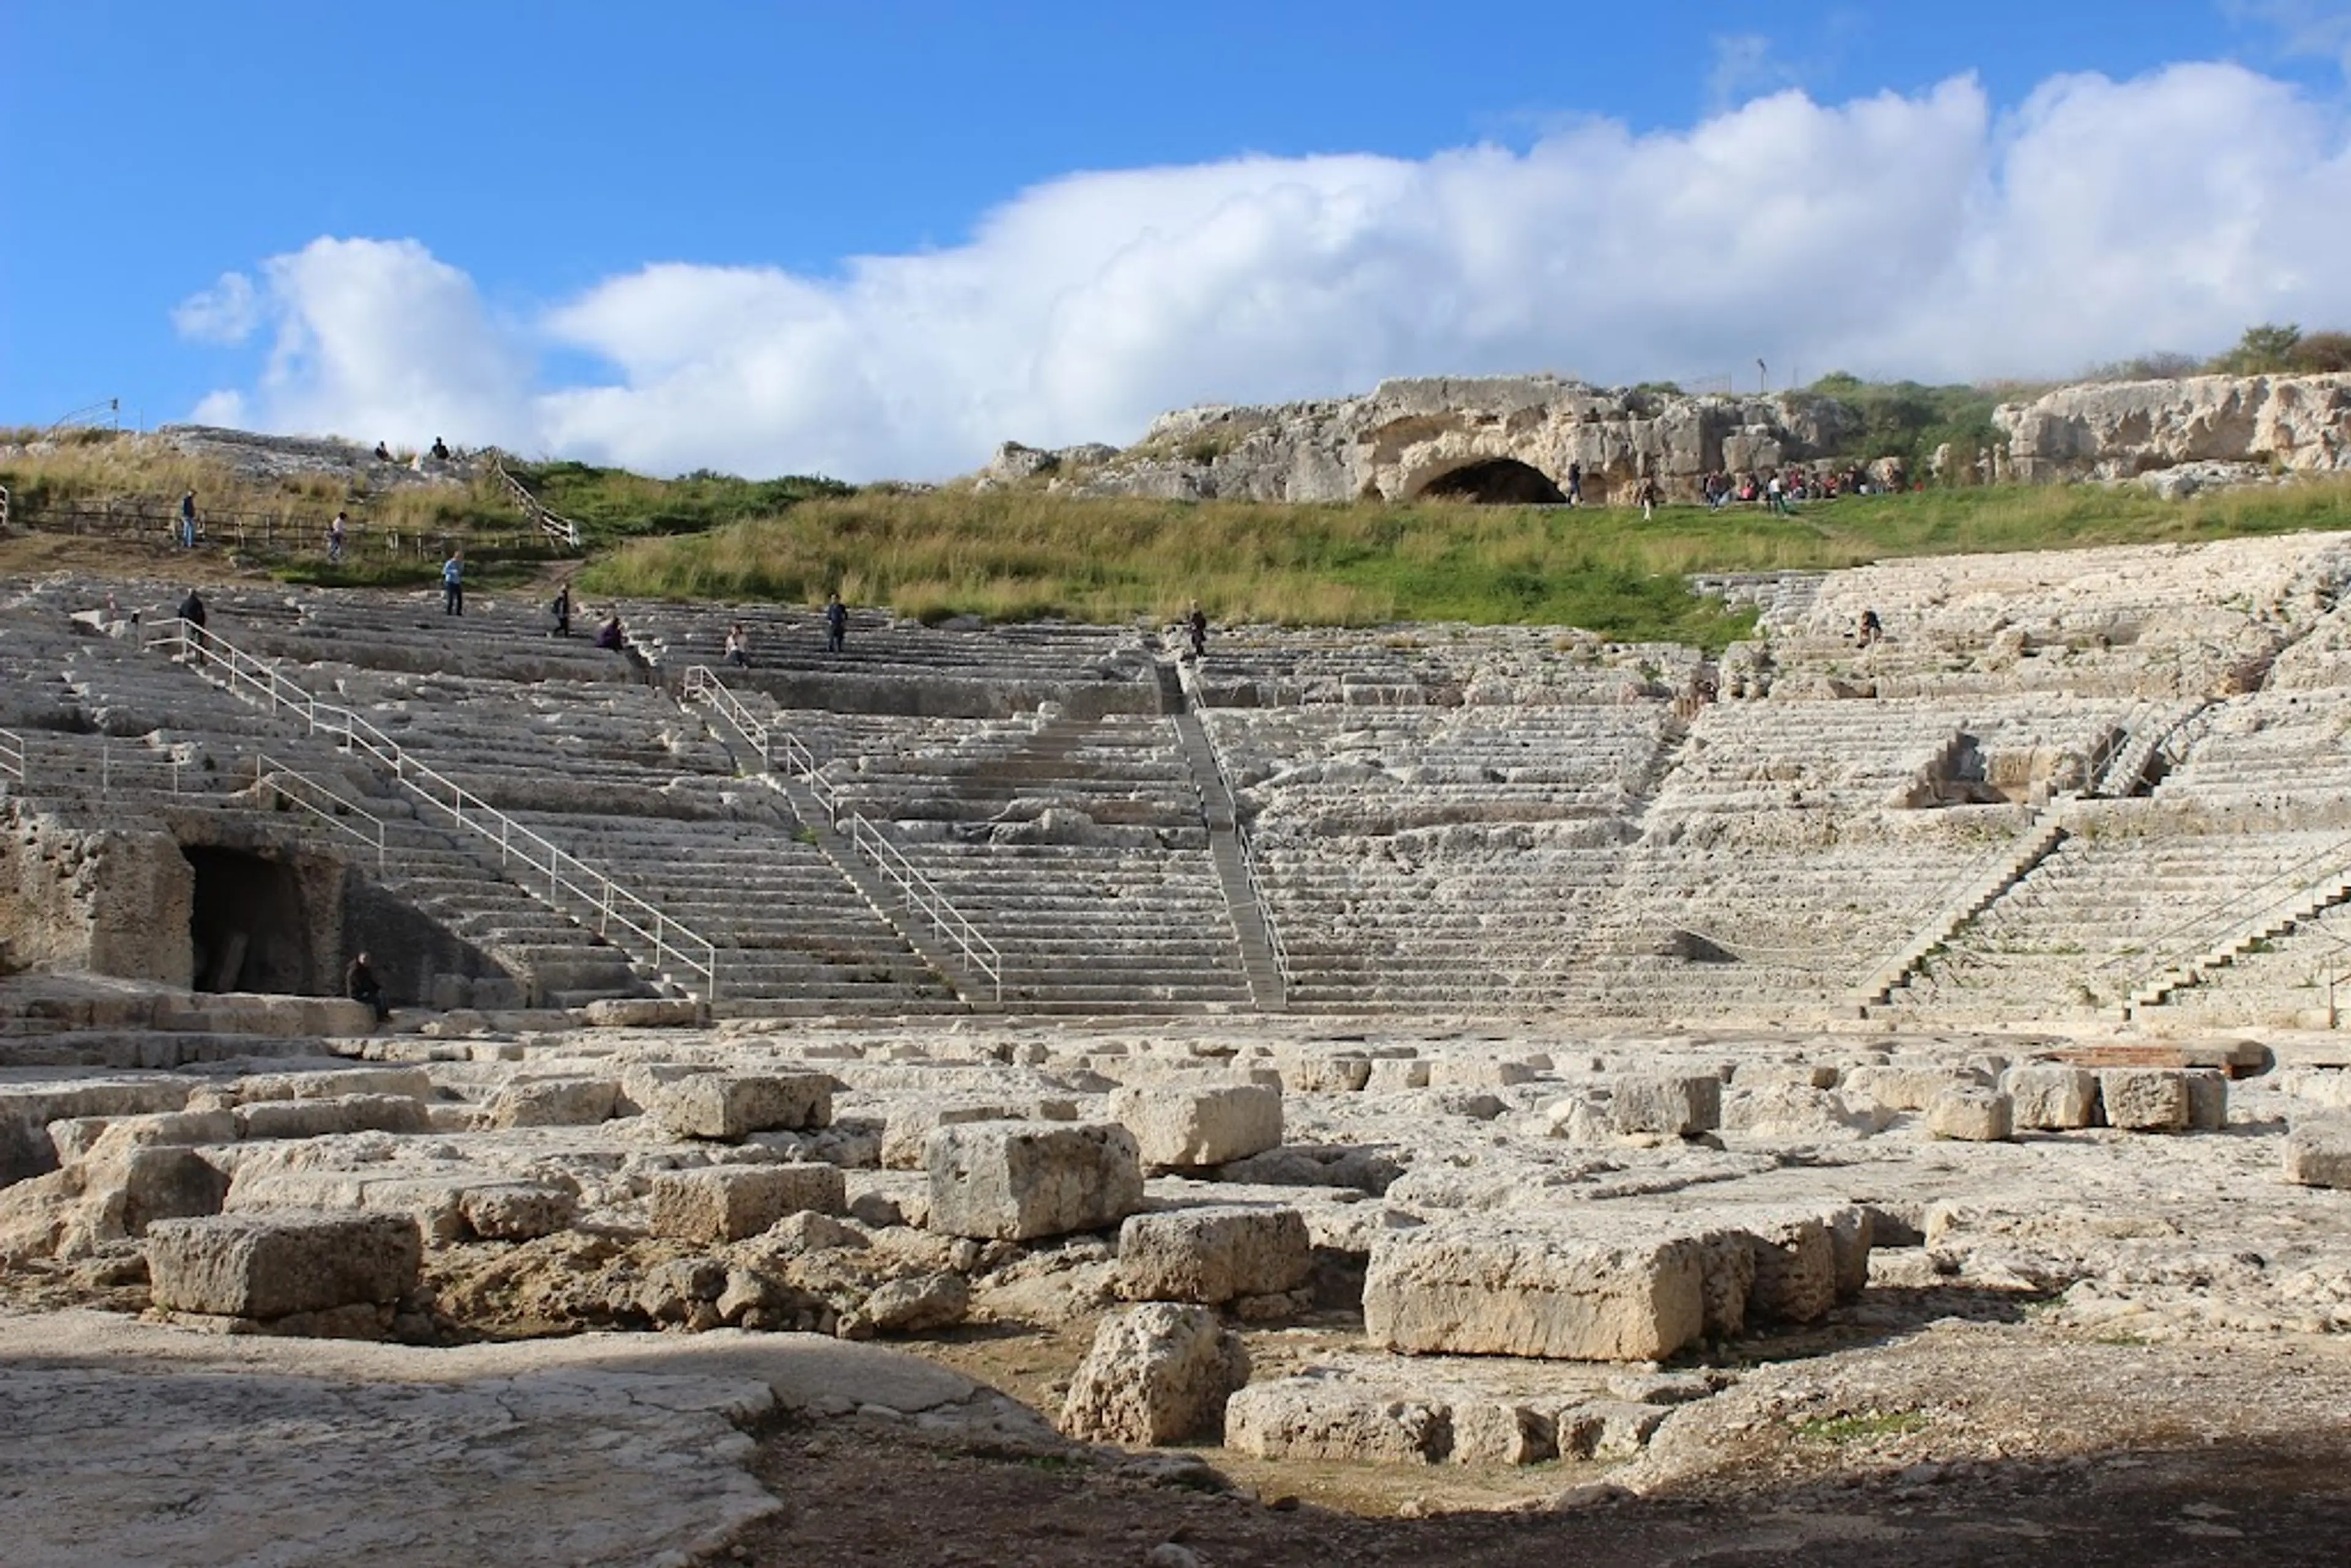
1363,1220,1711,1361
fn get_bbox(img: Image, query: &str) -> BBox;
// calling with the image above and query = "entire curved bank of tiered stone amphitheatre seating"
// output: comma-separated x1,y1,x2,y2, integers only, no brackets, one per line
13,536,2351,1022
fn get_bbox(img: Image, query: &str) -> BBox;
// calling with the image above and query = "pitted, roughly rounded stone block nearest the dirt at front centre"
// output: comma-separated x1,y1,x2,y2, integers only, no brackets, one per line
1060,1302,1248,1444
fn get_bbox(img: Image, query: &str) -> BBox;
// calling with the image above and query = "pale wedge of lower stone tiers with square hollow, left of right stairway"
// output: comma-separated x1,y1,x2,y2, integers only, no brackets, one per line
1570,698,2130,1018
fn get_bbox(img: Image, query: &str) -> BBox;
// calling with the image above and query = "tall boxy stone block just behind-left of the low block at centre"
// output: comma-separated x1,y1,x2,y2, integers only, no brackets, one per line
924,1121,1142,1241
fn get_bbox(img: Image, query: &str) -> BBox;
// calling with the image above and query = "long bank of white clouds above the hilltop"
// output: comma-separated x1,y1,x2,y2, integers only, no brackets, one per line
188,64,2351,479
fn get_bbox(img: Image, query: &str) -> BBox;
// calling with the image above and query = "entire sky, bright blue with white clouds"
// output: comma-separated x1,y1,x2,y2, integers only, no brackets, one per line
0,0,2351,477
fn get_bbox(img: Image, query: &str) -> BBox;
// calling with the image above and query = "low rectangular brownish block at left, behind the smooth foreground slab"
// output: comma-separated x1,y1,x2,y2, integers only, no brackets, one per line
146,1210,423,1319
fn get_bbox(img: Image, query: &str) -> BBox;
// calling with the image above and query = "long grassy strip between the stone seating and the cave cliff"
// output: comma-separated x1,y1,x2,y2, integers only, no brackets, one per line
583,482,2351,649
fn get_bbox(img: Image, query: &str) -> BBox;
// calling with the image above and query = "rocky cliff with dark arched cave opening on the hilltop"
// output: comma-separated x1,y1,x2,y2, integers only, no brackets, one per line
1020,376,1859,501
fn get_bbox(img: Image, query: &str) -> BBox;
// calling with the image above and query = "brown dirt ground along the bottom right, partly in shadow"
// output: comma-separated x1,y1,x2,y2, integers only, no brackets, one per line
736,1324,2351,1568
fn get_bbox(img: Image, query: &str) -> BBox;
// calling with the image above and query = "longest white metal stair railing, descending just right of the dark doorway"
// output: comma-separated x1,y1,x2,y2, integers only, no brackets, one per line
146,621,717,1002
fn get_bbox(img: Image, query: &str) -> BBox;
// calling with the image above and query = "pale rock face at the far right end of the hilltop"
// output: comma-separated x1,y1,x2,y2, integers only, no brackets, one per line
1991,376,2351,479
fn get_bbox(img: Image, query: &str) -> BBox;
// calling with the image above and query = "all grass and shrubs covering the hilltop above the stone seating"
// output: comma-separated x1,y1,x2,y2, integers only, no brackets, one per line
13,352,2351,647
